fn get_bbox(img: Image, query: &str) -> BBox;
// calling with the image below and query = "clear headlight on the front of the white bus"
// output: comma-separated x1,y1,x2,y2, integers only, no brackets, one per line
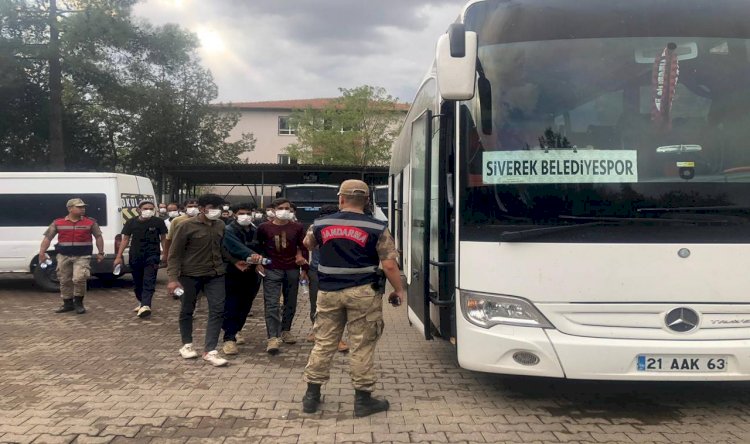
461,291,554,328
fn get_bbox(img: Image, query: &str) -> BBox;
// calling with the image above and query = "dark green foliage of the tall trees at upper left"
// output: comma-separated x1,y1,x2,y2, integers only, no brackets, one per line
0,0,255,188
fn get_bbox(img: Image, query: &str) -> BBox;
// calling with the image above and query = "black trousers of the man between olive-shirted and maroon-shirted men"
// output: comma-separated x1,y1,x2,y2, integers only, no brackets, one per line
222,267,261,341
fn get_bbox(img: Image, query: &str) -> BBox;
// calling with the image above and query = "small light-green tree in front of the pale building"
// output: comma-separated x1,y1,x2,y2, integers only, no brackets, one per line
286,85,404,166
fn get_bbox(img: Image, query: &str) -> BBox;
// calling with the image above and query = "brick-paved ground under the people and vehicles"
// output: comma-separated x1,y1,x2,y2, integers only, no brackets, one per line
0,275,750,444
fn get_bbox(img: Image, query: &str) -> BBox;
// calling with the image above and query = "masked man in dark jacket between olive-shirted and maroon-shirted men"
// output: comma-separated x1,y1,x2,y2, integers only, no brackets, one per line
222,203,261,355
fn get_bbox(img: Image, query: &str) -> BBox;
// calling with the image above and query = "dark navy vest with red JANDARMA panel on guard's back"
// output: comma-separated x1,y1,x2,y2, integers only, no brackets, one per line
313,211,386,291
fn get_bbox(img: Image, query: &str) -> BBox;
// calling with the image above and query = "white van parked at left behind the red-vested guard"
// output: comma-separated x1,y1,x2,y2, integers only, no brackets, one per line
0,173,156,291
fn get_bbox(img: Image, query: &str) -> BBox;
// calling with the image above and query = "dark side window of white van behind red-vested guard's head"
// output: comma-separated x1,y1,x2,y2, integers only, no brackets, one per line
0,193,107,227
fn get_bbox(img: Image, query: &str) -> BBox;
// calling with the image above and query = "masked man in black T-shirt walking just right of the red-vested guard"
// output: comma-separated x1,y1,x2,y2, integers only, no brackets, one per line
114,200,167,318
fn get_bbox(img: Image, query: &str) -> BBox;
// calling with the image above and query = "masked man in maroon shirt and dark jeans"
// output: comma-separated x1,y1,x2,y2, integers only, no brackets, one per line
257,199,307,355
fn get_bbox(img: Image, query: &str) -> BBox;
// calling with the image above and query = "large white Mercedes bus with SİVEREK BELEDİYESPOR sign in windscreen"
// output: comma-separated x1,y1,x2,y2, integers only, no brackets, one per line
389,0,750,380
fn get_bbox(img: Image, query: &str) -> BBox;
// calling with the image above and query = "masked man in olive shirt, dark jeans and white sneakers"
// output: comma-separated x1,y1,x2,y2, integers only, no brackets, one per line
167,194,242,367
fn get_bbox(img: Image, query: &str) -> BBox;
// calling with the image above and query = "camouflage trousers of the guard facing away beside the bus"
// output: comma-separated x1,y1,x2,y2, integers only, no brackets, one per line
304,285,383,392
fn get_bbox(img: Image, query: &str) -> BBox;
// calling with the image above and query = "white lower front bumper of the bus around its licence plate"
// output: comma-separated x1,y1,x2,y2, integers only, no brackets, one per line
457,317,750,381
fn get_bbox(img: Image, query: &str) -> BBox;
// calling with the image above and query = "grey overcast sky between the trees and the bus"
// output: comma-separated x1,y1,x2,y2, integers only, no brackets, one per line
135,0,465,102
